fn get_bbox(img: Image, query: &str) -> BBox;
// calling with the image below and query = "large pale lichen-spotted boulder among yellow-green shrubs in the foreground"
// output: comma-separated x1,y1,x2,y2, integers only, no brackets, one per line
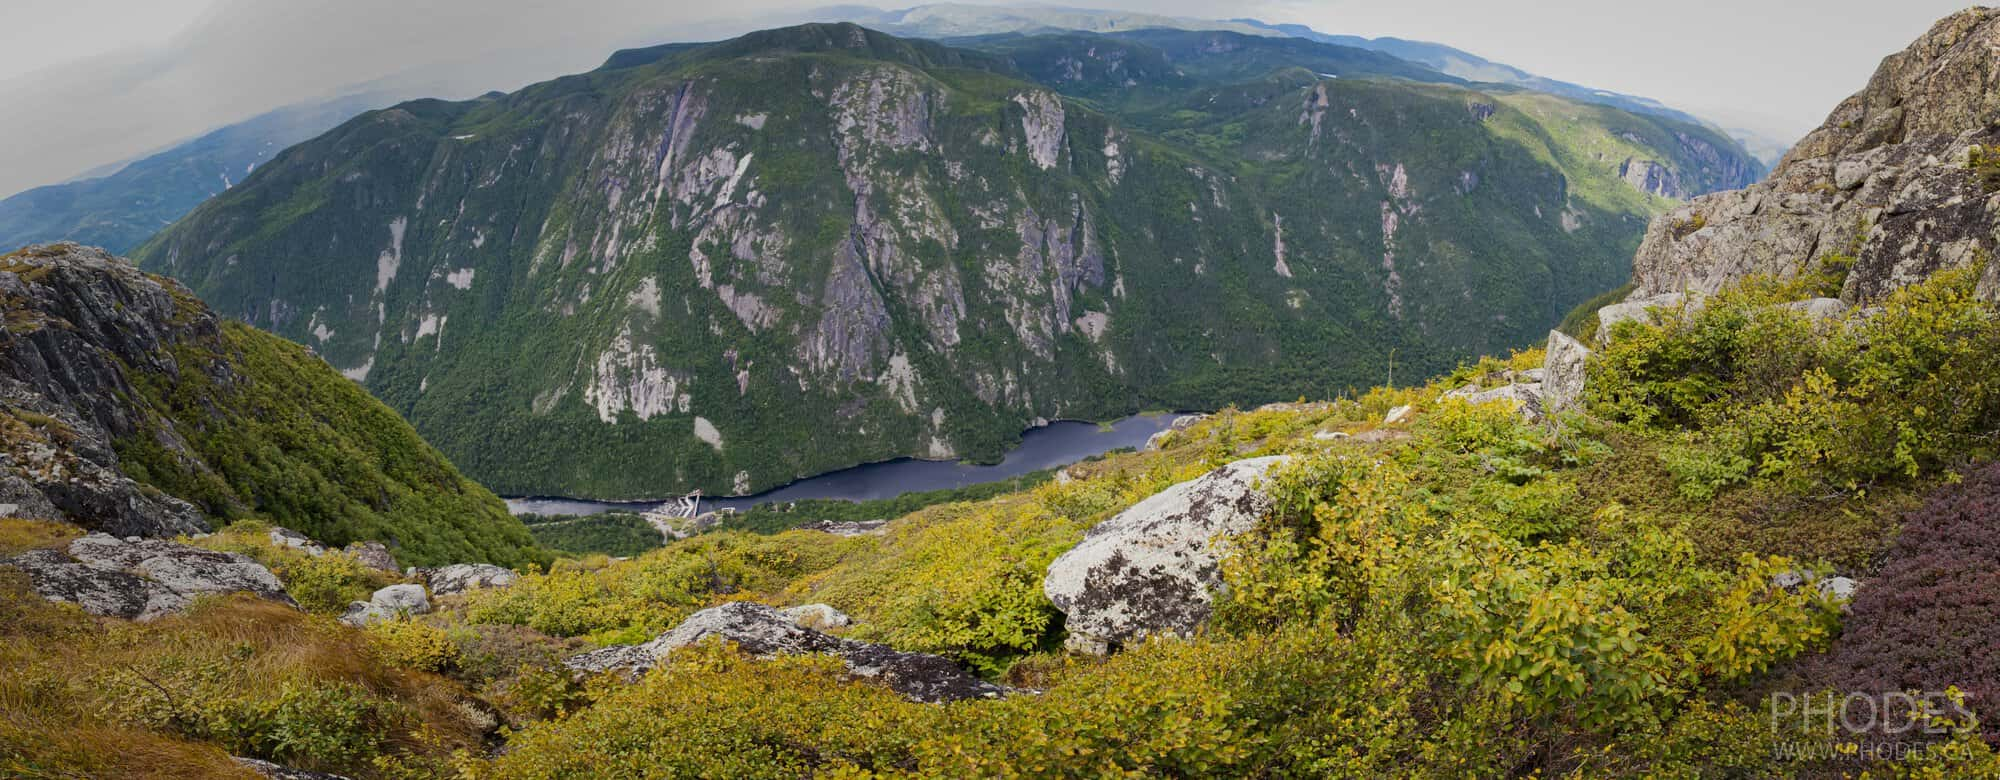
1042,456,1288,654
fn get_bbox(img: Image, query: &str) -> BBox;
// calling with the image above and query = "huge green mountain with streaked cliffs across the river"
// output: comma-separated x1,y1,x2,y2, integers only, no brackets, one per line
136,24,1756,498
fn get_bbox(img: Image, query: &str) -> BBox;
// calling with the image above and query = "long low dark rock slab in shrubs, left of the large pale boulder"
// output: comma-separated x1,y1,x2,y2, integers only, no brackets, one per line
564,602,1008,704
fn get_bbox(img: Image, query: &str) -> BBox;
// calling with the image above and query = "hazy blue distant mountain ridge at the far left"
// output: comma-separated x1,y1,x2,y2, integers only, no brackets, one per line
0,94,394,252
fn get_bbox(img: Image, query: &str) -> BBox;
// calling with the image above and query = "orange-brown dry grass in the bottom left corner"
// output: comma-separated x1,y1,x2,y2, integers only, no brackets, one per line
0,570,490,778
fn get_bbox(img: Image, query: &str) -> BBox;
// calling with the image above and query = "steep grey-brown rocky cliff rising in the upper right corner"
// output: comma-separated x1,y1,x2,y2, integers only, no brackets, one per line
1632,8,2000,304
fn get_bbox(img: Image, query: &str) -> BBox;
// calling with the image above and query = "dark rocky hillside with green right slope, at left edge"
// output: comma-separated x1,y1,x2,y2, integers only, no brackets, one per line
0,244,538,566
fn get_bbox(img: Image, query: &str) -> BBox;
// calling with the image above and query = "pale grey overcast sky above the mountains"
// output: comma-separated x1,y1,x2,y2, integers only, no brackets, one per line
0,0,1964,194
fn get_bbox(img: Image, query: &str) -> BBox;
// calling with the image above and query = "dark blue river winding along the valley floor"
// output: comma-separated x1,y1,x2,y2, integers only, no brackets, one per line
506,414,1176,514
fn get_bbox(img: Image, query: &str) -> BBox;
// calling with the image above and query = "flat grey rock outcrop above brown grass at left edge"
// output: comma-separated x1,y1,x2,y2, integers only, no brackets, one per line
0,534,298,620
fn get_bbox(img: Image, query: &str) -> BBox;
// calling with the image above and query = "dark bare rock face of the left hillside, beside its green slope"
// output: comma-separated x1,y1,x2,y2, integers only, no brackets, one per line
0,244,218,536
